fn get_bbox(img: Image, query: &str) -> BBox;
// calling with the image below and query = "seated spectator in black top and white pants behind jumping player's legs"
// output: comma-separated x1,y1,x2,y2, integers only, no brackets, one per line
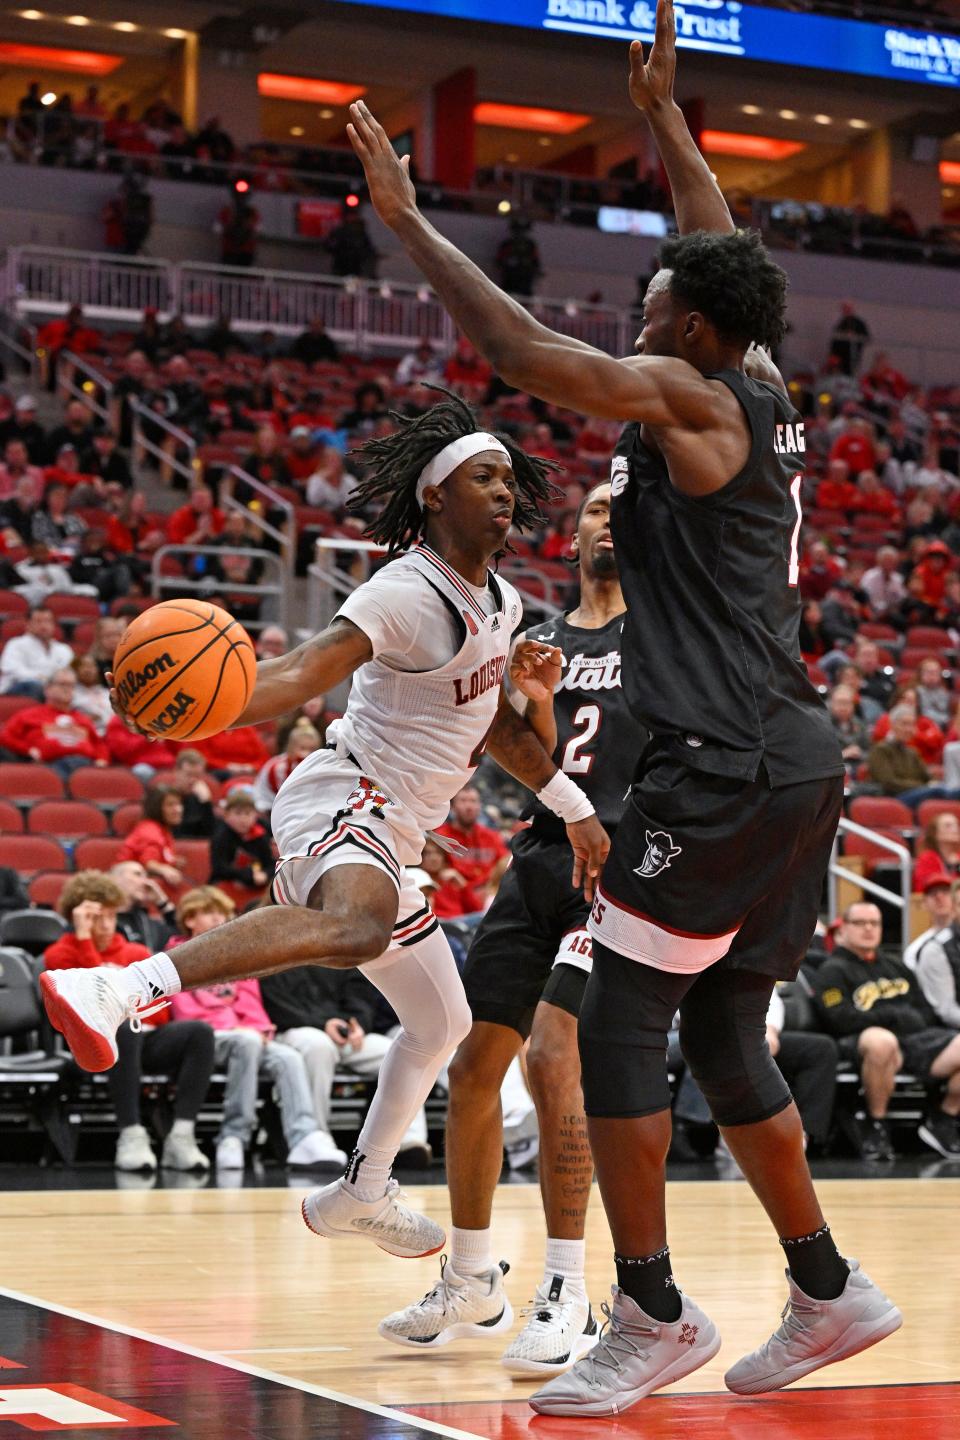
262,965,432,1166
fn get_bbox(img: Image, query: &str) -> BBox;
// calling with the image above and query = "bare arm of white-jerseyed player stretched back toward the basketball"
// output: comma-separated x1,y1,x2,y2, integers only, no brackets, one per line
235,619,373,726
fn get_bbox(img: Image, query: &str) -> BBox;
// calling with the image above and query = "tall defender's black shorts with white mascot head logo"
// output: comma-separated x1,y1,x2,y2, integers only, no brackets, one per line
589,744,843,979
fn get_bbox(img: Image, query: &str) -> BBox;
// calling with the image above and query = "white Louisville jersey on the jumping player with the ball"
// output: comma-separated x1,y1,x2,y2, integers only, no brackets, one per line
326,544,522,831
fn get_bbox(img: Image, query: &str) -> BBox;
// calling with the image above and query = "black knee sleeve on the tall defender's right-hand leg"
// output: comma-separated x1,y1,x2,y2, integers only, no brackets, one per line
679,972,792,1125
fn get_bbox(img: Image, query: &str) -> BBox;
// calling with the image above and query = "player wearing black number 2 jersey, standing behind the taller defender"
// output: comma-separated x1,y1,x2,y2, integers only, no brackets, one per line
380,481,645,1377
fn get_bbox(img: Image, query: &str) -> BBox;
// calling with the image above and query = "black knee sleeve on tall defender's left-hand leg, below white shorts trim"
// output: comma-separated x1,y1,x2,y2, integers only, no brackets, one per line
577,940,689,1119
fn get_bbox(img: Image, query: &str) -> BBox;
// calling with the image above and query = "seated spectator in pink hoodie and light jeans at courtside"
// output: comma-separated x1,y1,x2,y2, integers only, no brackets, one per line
171,886,347,1169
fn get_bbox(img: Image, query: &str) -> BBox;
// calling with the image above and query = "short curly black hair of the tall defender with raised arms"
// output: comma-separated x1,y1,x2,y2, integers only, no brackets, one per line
661,230,787,350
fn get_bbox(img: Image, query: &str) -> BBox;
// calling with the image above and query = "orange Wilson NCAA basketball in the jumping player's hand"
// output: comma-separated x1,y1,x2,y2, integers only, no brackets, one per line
114,599,256,740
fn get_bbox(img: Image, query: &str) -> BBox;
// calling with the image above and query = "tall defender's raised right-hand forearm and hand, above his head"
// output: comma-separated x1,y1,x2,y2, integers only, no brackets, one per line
630,0,735,235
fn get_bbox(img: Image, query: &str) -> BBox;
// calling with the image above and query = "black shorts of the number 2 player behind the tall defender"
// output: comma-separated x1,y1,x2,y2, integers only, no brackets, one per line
463,829,592,1040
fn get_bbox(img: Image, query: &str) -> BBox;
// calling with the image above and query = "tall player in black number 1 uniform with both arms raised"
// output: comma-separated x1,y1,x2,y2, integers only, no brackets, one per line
348,0,902,1416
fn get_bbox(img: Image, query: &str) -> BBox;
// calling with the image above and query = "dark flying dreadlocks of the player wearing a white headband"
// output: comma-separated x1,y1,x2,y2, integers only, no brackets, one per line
350,384,561,556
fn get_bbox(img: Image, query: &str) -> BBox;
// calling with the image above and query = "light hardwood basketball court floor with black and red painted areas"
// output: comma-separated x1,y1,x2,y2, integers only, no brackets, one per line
0,1166,960,1440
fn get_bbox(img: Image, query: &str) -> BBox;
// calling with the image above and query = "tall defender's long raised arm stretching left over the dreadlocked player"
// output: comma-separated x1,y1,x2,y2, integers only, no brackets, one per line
347,101,718,431
